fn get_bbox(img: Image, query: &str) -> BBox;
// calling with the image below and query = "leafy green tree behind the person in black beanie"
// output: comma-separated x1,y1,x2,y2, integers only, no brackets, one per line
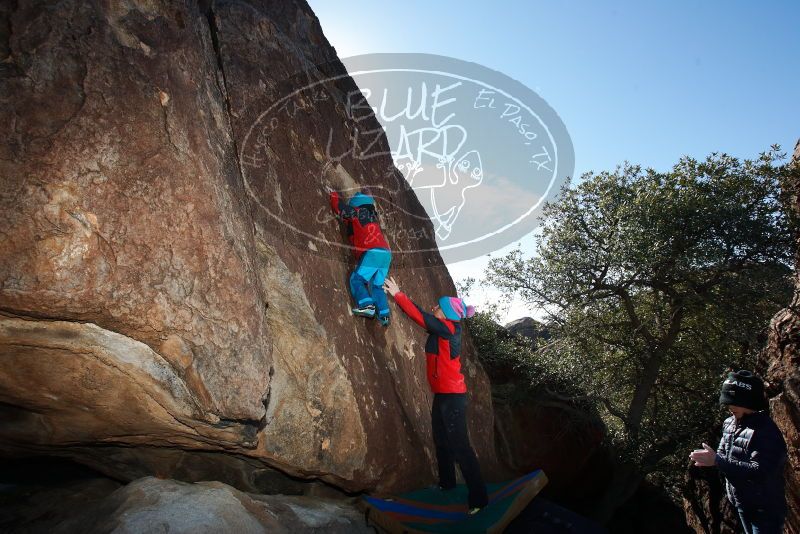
487,147,793,514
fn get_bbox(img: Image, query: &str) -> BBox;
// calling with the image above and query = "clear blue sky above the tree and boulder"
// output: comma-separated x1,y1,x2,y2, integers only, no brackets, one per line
310,0,800,318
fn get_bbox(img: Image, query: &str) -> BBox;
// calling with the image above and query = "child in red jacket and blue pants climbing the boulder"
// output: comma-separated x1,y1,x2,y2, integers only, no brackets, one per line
330,191,392,326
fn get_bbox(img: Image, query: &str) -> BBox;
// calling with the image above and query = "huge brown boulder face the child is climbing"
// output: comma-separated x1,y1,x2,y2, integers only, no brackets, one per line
0,0,495,491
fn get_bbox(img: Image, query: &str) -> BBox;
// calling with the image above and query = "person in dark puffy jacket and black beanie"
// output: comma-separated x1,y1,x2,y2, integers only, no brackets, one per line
689,370,786,534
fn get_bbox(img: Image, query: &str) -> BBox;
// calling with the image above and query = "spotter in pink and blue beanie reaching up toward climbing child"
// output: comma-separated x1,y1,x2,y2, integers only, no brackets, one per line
384,278,489,514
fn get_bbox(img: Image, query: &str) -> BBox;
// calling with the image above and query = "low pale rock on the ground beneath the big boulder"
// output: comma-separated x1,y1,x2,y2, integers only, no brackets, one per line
0,477,372,534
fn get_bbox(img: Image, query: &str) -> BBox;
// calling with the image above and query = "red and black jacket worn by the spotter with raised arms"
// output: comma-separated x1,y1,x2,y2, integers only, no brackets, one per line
394,292,467,393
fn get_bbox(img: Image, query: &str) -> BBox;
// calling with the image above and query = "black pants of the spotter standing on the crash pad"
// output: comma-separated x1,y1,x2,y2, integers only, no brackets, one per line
431,393,489,508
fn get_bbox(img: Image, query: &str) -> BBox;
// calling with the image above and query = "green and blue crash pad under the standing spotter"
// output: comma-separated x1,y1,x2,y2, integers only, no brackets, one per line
362,469,547,534
